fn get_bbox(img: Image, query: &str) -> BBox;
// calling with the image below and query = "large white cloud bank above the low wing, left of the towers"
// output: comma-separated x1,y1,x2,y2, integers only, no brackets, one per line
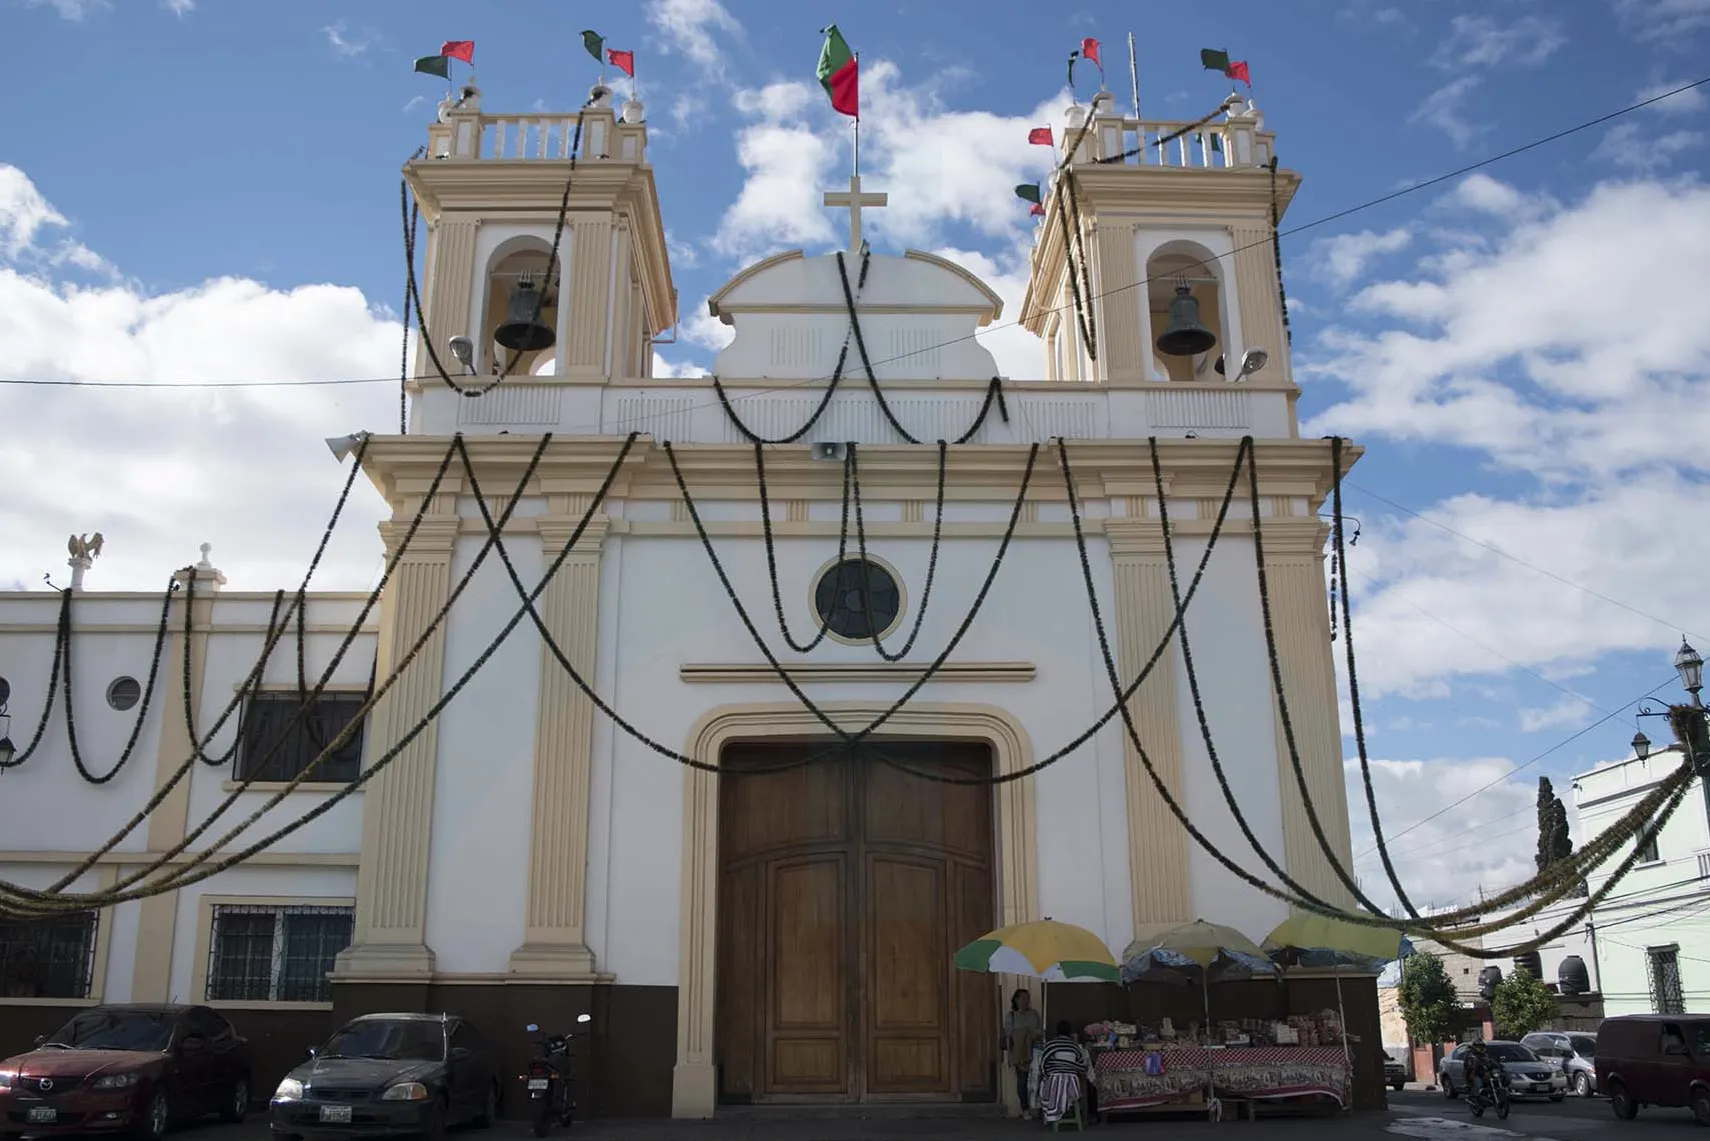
0,166,400,590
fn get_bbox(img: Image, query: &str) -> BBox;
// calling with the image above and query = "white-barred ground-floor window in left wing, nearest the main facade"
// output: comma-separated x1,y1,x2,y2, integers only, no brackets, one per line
207,903,356,1002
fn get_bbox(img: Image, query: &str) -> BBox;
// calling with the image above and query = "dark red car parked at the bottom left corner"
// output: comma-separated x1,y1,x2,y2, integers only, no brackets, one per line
0,1006,250,1141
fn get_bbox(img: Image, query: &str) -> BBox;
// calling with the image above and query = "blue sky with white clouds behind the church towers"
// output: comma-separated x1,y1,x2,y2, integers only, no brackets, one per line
0,0,1710,902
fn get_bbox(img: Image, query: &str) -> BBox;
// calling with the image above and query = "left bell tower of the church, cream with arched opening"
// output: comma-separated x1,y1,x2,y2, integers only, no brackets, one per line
404,84,677,405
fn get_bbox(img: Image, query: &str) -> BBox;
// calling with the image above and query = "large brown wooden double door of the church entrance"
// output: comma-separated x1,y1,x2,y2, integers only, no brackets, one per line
715,742,1000,1103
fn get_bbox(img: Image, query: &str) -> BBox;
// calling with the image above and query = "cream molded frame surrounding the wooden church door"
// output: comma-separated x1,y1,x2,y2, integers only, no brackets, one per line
670,701,1040,1117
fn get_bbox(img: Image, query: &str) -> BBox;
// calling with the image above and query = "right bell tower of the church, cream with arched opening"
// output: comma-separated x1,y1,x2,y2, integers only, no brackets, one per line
1021,91,1300,387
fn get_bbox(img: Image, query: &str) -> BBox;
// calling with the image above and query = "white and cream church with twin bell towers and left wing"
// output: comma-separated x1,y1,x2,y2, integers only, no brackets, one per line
0,91,1378,1117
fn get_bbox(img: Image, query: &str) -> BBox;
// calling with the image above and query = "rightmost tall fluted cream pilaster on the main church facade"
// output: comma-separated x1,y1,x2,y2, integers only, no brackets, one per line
1262,517,1354,907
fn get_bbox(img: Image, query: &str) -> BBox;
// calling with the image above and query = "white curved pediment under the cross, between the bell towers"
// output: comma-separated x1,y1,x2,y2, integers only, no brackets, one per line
706,250,1004,380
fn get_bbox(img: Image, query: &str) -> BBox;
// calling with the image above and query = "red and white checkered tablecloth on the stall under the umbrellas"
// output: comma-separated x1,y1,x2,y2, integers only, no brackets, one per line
1094,1045,1353,1110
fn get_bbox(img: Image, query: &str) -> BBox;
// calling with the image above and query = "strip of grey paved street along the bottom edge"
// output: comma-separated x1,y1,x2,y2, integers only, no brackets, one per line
140,1090,1703,1141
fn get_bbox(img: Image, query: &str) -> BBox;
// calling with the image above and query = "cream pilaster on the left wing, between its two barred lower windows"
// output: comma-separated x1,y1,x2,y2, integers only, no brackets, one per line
130,557,225,1002
